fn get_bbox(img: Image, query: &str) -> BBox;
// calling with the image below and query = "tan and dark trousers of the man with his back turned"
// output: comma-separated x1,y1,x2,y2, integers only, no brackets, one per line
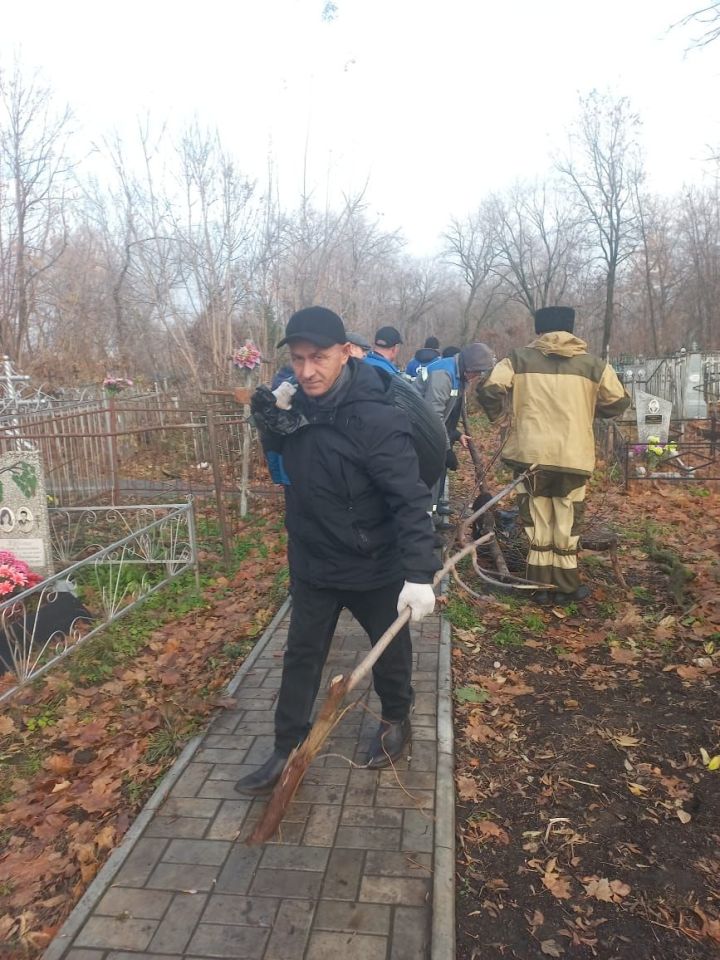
518,470,586,593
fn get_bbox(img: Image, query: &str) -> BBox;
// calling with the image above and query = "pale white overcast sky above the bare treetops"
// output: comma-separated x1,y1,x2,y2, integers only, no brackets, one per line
0,0,720,254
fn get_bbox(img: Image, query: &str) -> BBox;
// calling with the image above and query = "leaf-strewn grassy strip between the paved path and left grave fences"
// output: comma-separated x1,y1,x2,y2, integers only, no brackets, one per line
0,511,287,960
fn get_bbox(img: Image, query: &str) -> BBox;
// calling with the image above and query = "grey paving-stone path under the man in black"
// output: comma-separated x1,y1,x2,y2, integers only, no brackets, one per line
47,613,452,960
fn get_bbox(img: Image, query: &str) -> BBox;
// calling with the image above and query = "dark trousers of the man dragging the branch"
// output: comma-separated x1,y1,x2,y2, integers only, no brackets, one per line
275,580,412,756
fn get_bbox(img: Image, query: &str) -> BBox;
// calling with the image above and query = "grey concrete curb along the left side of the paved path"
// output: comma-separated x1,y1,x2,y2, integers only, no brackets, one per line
43,596,291,960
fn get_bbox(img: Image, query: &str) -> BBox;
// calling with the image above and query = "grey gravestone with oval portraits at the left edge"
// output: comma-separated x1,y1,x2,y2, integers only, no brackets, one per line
0,450,53,577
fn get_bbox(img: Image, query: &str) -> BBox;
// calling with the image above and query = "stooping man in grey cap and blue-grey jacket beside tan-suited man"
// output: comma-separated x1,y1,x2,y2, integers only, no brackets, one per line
418,343,495,520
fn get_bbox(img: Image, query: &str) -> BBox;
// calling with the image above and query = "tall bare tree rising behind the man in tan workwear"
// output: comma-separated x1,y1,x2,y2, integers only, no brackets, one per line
557,91,643,358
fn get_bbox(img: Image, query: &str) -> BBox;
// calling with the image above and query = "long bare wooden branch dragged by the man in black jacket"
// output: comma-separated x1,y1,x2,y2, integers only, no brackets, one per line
246,472,528,845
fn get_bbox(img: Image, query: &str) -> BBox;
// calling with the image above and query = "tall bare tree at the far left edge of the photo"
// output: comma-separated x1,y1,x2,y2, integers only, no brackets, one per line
0,64,70,360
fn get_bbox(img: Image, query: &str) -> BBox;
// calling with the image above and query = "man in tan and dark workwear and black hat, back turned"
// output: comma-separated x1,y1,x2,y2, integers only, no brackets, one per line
477,307,630,603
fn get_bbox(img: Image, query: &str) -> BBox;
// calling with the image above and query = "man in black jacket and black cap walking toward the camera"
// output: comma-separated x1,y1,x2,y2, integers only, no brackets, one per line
236,307,439,796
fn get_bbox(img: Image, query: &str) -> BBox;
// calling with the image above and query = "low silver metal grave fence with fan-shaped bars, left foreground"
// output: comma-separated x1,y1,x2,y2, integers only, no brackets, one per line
0,502,198,702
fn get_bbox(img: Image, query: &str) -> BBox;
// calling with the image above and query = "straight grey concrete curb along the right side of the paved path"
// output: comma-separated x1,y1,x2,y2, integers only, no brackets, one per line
430,581,455,960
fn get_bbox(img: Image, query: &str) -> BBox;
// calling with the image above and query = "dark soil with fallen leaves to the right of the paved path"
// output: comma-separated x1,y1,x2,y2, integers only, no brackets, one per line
448,454,720,960
